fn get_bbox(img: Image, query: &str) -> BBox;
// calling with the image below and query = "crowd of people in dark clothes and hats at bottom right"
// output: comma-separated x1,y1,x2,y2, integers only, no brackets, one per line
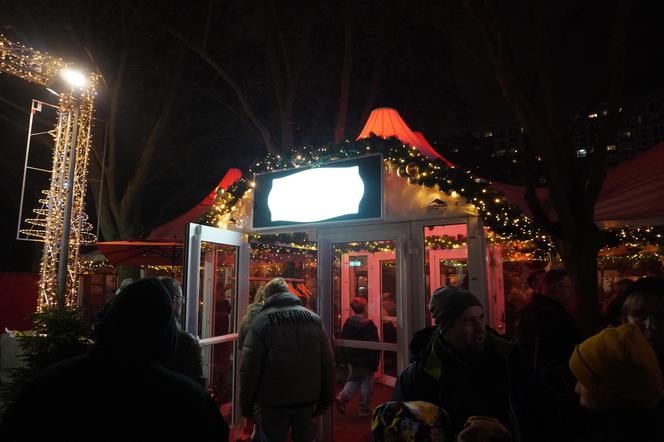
386,270,664,442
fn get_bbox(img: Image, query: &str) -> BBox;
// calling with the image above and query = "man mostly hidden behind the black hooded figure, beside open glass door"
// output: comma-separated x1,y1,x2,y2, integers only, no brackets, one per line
159,276,206,387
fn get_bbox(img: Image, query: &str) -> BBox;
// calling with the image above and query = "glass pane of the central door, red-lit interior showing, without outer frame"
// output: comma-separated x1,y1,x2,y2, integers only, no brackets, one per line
332,240,400,440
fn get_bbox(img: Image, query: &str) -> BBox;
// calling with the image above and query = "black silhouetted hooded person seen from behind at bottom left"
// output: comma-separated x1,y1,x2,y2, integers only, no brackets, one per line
0,278,228,442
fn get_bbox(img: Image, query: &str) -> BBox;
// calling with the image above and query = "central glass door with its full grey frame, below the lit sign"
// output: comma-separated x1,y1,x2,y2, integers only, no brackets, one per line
318,224,410,440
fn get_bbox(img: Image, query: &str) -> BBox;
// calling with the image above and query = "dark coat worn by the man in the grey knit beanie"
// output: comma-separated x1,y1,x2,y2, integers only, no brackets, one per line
392,329,513,434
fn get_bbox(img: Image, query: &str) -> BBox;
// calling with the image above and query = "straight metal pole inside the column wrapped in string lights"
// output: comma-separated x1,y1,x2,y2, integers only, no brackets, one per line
57,103,78,310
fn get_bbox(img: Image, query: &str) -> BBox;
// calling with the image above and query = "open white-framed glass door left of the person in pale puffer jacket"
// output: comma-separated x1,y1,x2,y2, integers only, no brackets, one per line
184,224,249,431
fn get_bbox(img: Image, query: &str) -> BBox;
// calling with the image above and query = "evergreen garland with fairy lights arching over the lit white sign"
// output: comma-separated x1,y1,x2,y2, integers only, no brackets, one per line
201,136,664,260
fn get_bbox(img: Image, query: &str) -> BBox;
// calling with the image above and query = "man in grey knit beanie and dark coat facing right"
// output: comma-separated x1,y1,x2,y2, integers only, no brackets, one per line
392,286,512,435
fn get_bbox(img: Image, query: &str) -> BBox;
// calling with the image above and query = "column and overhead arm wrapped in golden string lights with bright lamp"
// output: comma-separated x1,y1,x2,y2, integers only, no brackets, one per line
0,35,98,311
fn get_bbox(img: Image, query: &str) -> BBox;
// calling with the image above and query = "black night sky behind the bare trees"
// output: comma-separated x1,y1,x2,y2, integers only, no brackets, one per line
0,0,664,271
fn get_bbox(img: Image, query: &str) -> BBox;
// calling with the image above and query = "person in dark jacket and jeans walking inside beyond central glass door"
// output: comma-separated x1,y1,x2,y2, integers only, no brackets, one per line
335,297,380,416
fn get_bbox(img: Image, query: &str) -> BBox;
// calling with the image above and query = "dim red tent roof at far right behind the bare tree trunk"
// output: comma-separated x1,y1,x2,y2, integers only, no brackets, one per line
492,143,664,228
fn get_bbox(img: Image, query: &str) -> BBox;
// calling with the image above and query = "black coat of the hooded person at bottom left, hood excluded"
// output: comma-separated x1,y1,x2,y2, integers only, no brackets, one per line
0,349,228,442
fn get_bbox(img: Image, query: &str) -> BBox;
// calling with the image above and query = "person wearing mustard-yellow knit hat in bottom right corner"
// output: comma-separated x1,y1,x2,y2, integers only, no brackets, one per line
569,324,664,442
